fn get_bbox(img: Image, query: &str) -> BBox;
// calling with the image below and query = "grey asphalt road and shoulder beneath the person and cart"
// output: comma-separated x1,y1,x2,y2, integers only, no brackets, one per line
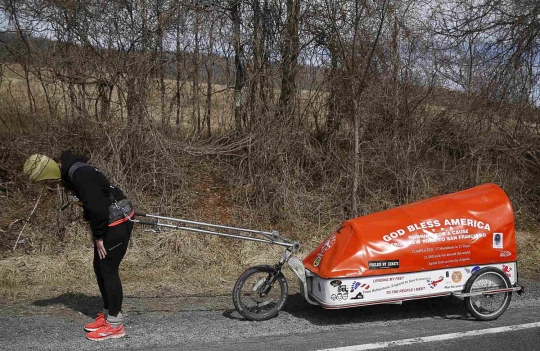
0,280,540,351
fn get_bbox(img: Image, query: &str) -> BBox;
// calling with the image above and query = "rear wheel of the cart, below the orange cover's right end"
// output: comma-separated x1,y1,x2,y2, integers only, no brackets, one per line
464,267,512,321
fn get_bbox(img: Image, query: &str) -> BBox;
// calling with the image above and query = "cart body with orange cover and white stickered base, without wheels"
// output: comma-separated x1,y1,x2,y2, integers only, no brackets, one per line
303,184,517,308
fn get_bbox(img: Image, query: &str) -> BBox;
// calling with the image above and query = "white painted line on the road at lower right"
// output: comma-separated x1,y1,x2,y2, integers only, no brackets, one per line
319,322,540,351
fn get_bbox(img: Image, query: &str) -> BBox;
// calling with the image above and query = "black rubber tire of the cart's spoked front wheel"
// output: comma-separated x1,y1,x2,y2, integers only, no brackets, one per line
233,265,289,321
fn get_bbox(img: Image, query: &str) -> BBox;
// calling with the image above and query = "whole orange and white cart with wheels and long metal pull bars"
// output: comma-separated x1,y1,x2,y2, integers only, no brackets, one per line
133,184,523,320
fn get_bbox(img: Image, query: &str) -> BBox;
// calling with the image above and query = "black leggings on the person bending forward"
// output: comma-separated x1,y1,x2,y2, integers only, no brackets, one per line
94,221,133,316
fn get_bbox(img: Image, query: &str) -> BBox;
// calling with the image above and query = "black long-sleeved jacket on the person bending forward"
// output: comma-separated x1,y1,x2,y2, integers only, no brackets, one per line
61,150,126,239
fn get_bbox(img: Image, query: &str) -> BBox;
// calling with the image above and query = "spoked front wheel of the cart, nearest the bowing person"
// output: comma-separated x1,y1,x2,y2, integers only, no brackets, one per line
233,266,288,321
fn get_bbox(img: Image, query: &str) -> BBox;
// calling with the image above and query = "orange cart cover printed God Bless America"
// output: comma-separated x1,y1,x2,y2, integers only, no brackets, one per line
303,184,517,278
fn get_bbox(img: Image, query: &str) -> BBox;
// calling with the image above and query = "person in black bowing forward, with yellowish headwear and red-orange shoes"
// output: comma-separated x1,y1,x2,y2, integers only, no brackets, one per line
23,150,134,341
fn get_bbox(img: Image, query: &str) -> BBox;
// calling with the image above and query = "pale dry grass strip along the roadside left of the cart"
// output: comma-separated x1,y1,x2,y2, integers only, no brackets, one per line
0,214,326,301
